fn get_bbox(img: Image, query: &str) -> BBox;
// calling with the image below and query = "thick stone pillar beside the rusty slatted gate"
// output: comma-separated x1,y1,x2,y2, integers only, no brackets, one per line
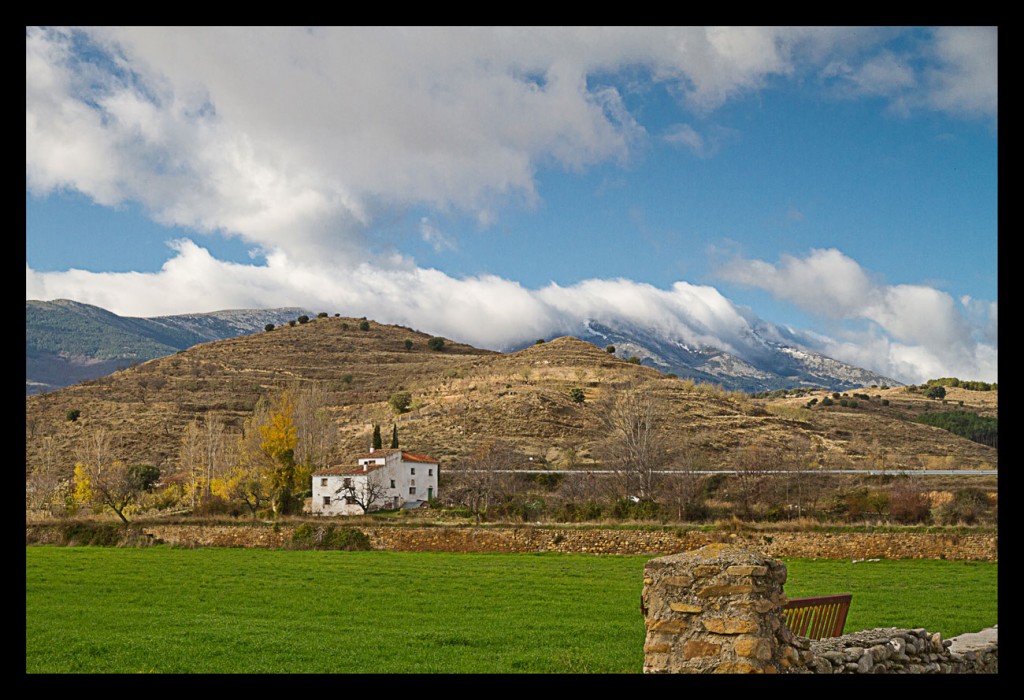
640,544,794,673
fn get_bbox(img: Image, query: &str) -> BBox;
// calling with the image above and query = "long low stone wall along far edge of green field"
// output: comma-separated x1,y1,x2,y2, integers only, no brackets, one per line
27,518,998,561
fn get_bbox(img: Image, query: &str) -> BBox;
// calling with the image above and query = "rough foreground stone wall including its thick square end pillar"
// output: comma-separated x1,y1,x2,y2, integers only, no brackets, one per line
641,544,998,674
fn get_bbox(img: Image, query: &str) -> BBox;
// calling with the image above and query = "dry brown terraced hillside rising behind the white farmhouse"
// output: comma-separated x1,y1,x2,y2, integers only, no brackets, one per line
26,317,997,487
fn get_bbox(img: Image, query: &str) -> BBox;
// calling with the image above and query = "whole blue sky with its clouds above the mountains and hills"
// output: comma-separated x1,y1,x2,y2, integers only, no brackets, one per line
26,27,998,383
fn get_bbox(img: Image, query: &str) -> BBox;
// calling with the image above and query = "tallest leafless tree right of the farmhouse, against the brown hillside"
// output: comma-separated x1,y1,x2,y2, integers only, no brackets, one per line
600,385,670,499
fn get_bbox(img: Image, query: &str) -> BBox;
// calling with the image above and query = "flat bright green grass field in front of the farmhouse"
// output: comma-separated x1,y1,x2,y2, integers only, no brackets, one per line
26,546,997,673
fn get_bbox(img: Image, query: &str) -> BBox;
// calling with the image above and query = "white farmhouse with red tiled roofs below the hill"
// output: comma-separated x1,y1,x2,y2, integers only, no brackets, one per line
310,449,438,515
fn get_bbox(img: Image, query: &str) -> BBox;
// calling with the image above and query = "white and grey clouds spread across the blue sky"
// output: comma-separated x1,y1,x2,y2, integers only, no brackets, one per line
26,28,997,382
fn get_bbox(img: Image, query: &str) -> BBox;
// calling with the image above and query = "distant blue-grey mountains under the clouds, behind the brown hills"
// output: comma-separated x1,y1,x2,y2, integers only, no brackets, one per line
26,300,902,394
